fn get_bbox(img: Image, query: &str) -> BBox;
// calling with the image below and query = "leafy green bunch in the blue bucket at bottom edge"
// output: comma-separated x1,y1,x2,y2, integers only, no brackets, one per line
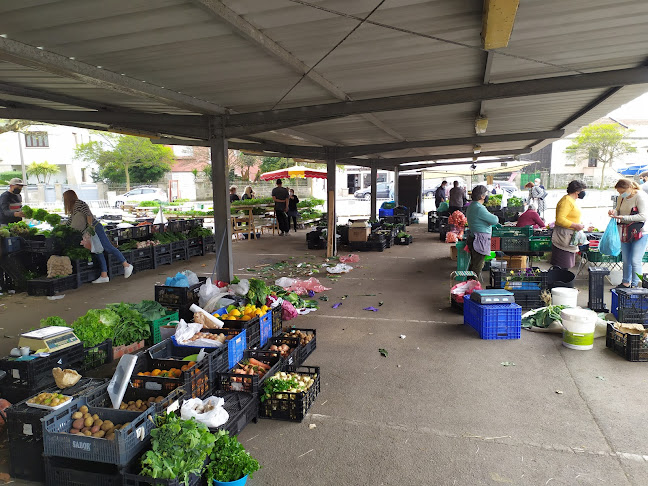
206,430,261,484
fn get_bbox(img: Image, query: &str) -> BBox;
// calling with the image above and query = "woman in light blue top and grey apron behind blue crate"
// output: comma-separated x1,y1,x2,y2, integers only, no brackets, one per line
466,185,499,282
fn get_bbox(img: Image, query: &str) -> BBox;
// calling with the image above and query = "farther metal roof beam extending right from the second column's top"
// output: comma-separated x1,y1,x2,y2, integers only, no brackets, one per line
338,130,565,158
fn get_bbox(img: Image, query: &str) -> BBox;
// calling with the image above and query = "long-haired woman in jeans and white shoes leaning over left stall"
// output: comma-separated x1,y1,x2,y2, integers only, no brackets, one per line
63,190,133,284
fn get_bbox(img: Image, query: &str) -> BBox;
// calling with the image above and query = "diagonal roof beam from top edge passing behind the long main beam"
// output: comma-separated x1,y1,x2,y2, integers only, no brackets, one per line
195,0,405,140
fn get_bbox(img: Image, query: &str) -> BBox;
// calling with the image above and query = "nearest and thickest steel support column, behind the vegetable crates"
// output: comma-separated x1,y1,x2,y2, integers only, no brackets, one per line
209,118,234,282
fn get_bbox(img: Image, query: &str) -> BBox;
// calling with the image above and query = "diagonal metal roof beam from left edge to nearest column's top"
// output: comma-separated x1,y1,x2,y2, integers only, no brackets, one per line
0,37,226,115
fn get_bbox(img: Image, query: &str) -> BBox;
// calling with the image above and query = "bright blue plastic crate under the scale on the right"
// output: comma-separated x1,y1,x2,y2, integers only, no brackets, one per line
464,296,522,339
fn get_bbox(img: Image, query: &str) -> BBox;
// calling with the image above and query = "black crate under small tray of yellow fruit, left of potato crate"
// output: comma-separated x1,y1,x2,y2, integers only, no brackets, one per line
5,378,106,446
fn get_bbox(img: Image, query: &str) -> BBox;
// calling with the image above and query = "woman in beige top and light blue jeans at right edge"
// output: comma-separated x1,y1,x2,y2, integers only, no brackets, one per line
608,179,648,288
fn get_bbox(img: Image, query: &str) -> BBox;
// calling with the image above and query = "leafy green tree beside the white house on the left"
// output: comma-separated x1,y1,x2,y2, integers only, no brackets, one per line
75,137,174,190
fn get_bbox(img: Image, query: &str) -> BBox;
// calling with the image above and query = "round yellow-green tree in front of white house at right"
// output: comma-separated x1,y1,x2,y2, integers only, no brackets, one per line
565,123,637,189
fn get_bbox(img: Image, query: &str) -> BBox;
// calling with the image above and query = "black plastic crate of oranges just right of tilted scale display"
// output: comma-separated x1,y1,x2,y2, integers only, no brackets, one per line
130,354,211,398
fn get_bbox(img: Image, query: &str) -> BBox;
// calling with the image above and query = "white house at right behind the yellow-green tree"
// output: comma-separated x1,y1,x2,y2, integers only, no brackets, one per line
551,117,648,187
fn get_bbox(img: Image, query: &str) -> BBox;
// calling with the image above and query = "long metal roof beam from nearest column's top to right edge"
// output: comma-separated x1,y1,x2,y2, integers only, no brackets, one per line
226,67,648,126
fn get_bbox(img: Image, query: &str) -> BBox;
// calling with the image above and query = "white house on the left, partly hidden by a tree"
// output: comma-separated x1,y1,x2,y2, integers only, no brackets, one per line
0,125,96,185
